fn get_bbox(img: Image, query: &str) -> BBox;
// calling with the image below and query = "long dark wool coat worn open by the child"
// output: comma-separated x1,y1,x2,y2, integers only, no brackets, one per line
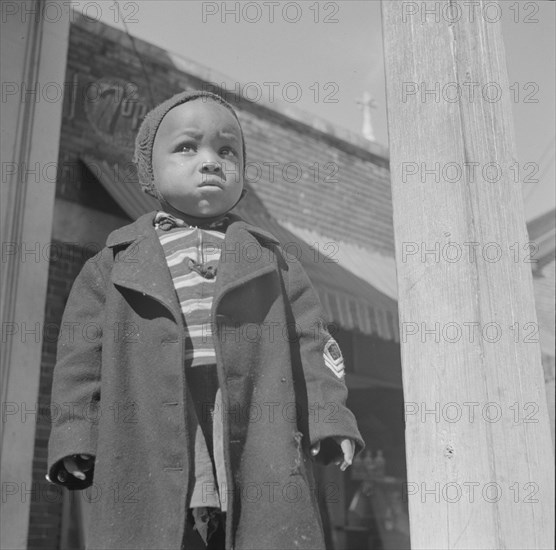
48,212,363,550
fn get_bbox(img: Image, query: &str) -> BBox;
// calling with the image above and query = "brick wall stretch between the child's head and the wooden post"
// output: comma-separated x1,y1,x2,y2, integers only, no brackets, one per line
241,112,394,255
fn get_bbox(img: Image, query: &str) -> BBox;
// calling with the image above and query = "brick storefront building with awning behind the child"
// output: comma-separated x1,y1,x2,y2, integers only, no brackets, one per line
28,11,405,549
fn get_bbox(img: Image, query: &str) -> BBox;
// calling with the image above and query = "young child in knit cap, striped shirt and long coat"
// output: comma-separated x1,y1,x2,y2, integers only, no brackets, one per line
48,92,364,550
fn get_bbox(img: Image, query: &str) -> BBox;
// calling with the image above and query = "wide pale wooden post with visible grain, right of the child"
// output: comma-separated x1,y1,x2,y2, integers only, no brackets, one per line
382,0,554,549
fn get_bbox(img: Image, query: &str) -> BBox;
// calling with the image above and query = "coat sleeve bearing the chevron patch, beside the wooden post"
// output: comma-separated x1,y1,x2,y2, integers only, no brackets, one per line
287,254,365,464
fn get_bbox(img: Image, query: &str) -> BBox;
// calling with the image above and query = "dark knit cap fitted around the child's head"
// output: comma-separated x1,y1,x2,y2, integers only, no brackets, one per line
133,90,245,199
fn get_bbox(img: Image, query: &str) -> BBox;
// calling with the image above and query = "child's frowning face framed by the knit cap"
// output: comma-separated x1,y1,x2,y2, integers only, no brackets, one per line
152,99,243,217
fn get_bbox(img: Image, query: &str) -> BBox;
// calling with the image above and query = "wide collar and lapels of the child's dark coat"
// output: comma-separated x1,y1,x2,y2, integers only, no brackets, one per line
106,212,279,319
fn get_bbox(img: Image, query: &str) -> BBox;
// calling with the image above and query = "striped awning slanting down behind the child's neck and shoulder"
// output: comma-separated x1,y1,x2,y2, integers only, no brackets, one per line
81,154,399,342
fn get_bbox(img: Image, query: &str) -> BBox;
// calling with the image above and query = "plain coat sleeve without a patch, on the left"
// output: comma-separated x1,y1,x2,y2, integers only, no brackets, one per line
48,252,105,489
